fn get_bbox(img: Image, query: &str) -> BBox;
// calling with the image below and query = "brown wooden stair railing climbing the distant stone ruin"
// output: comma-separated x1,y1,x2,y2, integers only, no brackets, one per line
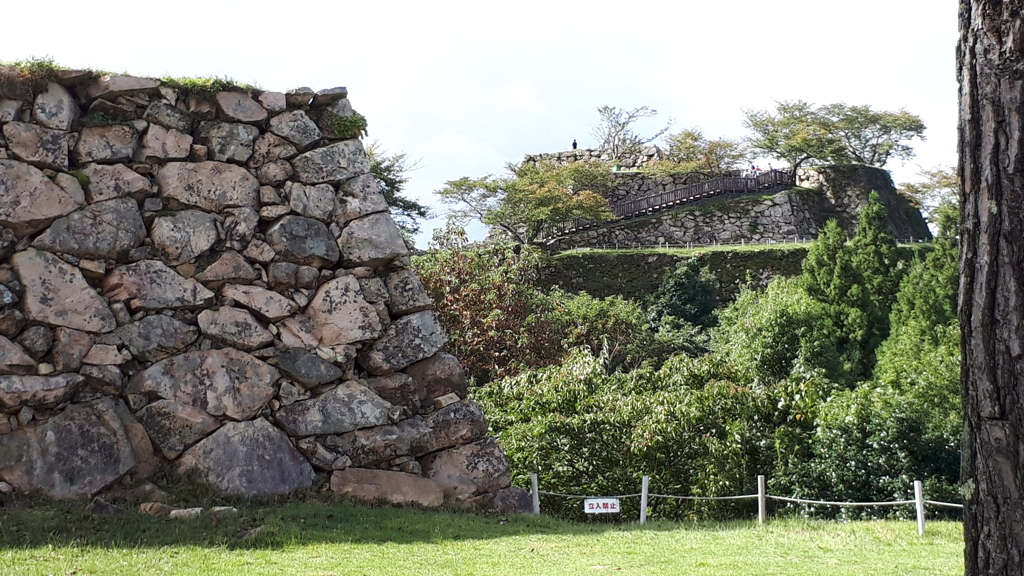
548,170,793,238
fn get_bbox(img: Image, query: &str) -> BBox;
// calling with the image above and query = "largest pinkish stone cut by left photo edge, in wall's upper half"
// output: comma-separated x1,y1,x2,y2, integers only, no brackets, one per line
0,160,78,238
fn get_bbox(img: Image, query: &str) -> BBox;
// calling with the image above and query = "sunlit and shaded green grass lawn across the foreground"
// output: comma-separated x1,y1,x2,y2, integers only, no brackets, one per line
0,494,964,576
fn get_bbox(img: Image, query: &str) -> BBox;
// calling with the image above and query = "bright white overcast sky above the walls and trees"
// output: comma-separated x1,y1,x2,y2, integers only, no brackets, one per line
0,0,957,242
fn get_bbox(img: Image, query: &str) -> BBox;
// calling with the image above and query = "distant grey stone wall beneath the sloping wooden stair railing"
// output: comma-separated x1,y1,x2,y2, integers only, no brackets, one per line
553,166,931,249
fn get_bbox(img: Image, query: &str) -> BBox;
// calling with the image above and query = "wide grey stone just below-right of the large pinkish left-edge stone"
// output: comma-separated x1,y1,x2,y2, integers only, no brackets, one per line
32,198,145,260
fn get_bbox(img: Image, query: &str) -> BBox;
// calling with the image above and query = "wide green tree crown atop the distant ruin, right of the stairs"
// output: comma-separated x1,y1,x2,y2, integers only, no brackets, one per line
743,100,925,169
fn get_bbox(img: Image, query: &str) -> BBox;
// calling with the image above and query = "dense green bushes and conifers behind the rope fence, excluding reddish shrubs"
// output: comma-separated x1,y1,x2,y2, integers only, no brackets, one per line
448,194,961,519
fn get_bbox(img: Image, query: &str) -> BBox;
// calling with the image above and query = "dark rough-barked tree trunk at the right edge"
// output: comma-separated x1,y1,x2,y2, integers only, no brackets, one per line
957,0,1024,576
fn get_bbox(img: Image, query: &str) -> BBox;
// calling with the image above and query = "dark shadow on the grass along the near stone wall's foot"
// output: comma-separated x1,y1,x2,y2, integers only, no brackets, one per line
0,487,752,549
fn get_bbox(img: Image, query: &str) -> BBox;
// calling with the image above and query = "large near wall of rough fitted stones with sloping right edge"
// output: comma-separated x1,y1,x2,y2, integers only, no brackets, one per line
0,69,521,505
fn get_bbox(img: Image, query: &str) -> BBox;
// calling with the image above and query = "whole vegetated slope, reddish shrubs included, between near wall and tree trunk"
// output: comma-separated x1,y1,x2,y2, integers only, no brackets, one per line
414,198,961,519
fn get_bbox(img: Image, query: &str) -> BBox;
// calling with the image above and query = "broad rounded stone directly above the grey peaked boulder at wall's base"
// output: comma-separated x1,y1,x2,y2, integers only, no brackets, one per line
128,348,280,420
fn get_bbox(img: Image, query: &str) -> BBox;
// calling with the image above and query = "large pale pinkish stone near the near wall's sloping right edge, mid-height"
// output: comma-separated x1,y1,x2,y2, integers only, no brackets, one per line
306,276,385,344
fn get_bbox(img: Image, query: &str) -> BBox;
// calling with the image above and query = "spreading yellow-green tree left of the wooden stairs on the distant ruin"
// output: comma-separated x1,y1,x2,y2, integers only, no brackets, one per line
437,162,614,244
